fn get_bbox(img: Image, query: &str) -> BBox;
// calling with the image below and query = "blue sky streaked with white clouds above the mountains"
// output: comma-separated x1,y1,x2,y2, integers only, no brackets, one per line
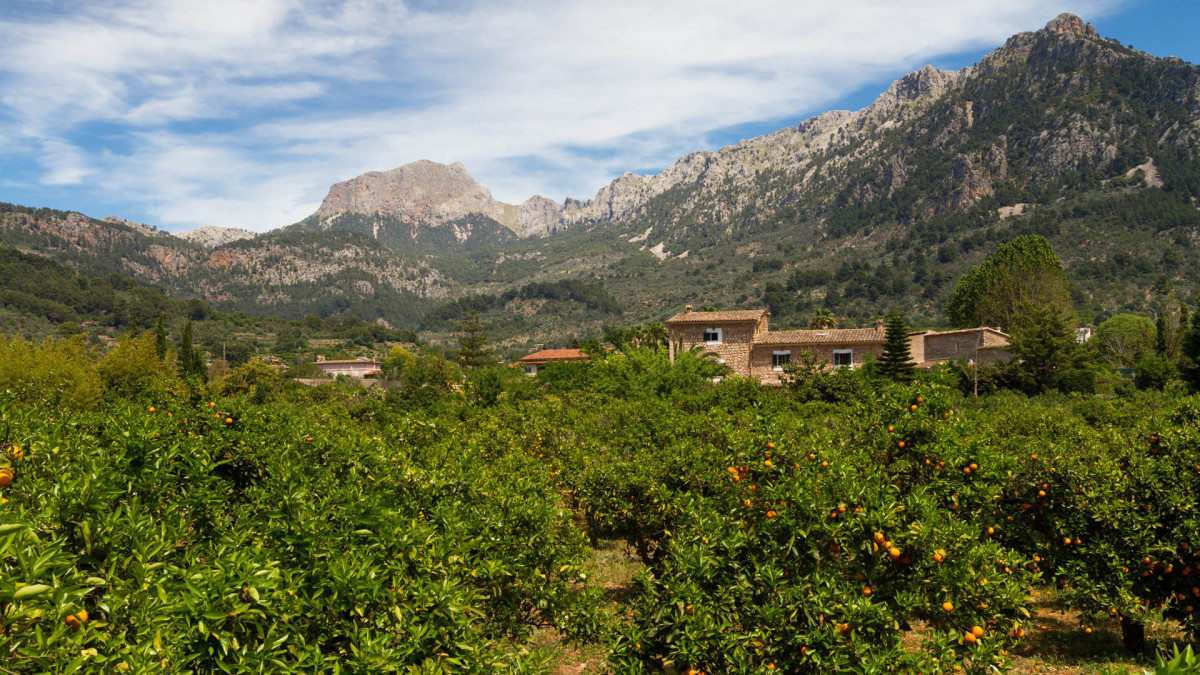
0,0,1200,232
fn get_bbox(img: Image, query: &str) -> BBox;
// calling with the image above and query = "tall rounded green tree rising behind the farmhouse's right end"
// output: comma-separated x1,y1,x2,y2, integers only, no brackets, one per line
946,235,1073,329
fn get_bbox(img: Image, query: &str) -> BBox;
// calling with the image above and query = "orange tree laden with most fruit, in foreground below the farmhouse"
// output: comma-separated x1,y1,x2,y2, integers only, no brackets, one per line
611,386,1036,673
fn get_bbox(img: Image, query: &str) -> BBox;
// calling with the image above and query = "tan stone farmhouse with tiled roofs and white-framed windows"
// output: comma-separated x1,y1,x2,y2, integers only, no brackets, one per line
666,305,1010,384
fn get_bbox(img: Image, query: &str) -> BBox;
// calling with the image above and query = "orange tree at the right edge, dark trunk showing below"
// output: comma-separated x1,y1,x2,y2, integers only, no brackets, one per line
974,394,1200,650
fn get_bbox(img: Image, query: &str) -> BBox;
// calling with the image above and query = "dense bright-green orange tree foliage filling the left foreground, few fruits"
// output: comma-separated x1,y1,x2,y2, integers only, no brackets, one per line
0,391,594,673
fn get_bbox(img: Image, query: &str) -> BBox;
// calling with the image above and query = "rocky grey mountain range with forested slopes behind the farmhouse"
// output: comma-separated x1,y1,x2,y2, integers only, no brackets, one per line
0,14,1200,345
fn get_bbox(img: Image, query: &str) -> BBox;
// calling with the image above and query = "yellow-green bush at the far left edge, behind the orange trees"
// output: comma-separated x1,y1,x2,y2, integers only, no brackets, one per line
0,335,102,411
